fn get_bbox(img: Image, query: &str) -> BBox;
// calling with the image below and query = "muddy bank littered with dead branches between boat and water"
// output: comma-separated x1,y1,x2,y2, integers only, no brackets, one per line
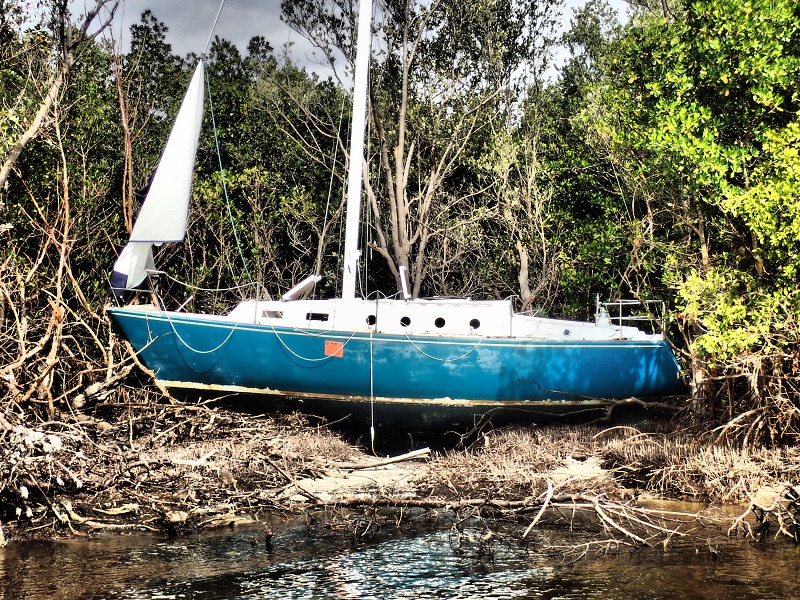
0,401,800,545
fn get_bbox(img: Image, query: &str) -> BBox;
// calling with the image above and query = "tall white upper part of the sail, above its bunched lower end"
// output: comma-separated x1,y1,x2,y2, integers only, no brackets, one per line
131,62,204,244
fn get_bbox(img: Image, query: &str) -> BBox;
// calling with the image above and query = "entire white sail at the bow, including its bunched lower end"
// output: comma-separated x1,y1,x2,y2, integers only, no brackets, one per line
111,62,204,296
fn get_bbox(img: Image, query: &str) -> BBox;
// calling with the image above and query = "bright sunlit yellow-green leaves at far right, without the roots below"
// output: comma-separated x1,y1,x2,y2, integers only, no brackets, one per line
602,0,800,359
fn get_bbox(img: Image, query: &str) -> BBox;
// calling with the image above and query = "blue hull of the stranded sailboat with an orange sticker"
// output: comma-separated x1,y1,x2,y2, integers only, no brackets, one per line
109,308,686,422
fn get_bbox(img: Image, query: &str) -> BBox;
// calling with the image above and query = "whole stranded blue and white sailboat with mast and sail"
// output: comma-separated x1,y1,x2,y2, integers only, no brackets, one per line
108,1,686,431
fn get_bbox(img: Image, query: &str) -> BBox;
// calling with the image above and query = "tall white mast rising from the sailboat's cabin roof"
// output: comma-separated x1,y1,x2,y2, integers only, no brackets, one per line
342,0,372,300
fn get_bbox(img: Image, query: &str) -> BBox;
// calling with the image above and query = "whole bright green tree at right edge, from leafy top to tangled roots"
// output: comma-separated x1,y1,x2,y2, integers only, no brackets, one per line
584,0,800,439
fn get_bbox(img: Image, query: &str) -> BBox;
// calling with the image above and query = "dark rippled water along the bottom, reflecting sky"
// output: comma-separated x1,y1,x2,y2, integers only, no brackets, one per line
0,524,800,600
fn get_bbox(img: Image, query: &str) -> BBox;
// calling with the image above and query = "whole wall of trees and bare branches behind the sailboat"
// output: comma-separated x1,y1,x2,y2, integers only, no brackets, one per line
0,0,800,439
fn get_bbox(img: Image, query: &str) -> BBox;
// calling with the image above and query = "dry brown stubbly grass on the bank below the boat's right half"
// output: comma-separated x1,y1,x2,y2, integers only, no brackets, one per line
418,426,800,504
